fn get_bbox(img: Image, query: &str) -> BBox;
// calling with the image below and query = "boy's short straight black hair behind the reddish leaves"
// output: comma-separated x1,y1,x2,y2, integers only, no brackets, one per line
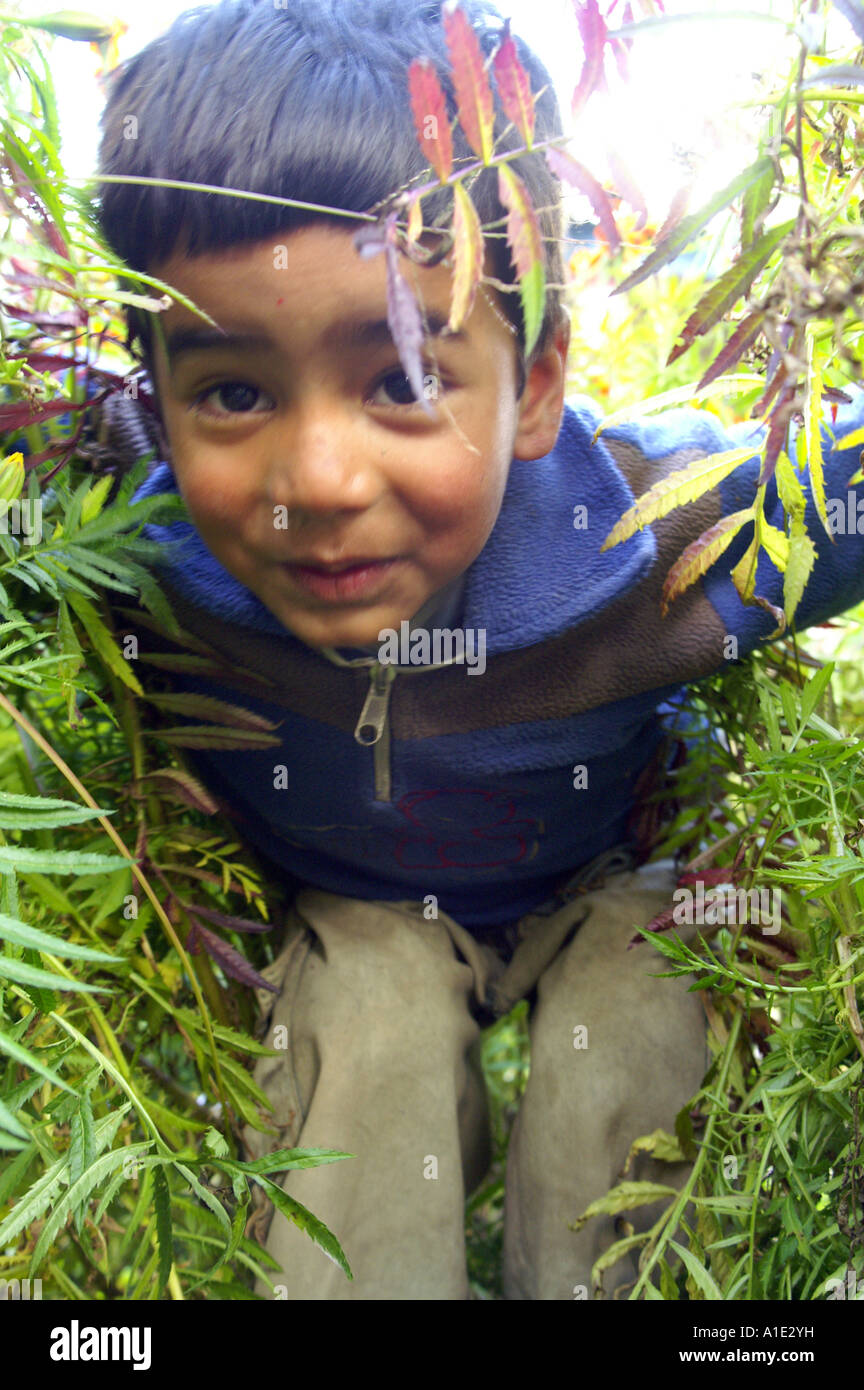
97,0,564,384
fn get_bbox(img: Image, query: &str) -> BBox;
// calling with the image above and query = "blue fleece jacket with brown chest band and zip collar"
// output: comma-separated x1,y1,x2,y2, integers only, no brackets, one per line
127,398,864,927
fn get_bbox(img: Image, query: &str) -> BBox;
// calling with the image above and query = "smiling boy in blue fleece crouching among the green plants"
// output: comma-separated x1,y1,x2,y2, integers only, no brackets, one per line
101,0,864,1300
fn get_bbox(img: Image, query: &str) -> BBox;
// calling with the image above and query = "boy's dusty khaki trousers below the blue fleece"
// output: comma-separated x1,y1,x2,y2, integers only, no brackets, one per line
244,862,708,1301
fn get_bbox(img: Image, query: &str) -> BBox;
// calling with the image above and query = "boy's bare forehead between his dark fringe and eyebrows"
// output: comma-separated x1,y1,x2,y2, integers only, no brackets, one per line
153,222,503,349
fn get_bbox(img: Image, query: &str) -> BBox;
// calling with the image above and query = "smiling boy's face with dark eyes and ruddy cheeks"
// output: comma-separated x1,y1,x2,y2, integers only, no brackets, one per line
154,224,568,646
